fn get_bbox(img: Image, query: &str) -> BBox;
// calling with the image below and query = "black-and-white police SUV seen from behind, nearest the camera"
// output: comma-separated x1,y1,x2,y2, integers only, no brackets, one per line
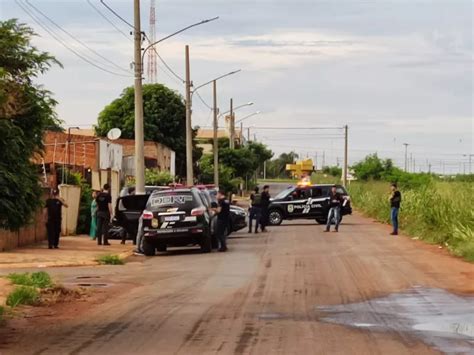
143,188,212,256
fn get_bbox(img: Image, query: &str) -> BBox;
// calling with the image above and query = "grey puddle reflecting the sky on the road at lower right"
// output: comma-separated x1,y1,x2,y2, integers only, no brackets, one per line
317,287,474,354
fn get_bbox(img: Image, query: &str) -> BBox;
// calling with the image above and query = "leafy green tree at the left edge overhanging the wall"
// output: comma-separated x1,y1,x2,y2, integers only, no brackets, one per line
0,20,61,230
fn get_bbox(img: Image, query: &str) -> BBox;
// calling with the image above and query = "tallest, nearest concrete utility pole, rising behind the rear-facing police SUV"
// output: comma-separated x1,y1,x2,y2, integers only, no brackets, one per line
133,0,145,195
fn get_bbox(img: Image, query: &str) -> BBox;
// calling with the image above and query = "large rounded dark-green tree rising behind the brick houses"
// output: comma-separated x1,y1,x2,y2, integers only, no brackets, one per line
95,84,202,176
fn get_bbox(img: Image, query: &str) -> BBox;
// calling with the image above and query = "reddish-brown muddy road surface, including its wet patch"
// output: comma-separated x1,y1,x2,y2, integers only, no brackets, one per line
0,215,474,354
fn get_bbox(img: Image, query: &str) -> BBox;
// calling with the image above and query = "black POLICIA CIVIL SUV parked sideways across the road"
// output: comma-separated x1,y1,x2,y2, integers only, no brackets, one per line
268,184,352,226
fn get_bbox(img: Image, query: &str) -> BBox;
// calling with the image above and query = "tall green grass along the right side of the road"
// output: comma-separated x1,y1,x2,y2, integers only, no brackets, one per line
349,182,474,261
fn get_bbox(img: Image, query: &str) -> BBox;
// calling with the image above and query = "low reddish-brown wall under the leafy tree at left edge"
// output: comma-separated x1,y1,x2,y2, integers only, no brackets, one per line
0,211,48,252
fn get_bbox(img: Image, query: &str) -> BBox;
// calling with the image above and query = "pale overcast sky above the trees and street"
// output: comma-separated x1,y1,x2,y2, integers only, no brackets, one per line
0,0,474,172
